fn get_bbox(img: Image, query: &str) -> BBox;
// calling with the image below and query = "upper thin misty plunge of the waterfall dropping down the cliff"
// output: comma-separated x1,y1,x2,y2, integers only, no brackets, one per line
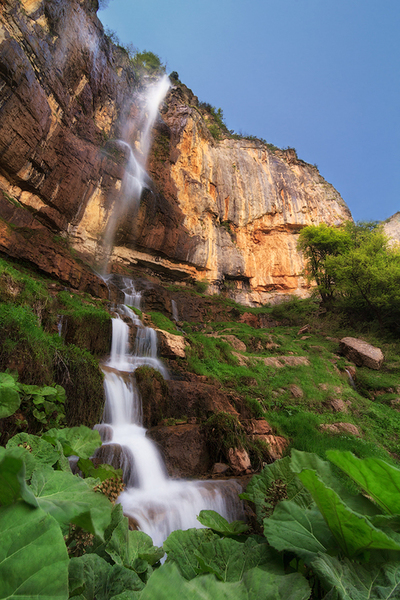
101,75,170,272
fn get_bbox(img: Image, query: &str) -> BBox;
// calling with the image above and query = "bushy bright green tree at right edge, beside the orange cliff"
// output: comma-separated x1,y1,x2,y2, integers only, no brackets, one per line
298,221,400,329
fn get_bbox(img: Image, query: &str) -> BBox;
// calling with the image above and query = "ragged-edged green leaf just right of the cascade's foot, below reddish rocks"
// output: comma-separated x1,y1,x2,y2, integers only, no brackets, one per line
240,456,312,523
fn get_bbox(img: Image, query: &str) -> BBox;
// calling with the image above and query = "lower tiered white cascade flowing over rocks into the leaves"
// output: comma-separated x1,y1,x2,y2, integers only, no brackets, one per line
97,279,241,545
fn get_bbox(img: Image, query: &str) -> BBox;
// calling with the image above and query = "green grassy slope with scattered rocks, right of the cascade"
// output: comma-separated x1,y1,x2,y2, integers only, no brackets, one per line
177,292,400,460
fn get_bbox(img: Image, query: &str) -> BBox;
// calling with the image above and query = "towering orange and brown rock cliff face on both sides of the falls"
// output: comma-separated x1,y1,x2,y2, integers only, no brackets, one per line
0,0,351,302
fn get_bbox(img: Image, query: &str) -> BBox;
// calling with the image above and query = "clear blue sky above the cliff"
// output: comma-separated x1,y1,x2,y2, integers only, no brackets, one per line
98,0,400,220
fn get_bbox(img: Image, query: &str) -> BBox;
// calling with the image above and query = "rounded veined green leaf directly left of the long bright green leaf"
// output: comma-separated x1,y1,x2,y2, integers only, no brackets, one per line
264,500,336,564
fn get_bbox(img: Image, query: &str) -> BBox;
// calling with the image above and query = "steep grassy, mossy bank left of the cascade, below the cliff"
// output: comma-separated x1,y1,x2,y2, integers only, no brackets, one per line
0,259,111,443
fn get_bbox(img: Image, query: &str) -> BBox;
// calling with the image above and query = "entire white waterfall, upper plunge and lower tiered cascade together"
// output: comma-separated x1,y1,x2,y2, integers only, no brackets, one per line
97,77,242,545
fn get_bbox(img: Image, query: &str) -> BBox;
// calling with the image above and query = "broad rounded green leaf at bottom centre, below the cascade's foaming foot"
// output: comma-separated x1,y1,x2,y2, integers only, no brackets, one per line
195,537,284,581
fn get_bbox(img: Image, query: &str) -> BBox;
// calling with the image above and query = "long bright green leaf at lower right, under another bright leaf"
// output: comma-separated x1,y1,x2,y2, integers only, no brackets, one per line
299,470,400,557
